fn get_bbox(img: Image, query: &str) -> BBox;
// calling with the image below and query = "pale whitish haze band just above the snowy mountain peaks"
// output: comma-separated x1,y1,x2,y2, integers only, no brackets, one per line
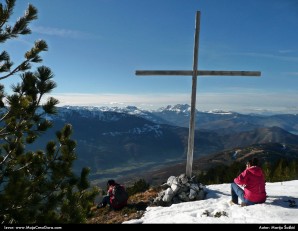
51,94,298,114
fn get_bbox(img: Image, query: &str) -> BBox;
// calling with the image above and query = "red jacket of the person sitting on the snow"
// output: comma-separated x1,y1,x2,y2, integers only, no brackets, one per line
234,166,266,203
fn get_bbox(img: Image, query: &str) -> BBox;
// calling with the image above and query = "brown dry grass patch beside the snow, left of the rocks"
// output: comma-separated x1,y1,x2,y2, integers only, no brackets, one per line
87,188,158,224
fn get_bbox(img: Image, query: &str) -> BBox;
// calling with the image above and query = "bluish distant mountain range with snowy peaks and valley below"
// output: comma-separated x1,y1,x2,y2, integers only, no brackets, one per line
33,105,298,186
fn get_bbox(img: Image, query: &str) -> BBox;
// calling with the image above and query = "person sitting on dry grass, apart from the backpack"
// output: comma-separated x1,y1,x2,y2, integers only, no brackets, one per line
97,179,127,210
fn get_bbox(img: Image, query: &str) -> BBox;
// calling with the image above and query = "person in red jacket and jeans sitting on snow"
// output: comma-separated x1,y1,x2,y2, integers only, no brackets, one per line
231,158,267,206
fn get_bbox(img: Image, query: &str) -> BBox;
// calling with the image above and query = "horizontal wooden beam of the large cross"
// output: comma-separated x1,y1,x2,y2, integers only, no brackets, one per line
136,70,261,77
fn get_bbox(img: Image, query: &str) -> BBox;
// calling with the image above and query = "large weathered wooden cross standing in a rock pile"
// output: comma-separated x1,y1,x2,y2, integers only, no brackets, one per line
136,11,261,178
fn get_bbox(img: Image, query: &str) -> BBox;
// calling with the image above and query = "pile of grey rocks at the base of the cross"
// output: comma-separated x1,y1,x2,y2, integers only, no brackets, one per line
152,174,207,206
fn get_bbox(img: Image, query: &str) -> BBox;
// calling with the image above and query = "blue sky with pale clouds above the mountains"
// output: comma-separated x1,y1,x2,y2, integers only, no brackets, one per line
1,0,298,113
